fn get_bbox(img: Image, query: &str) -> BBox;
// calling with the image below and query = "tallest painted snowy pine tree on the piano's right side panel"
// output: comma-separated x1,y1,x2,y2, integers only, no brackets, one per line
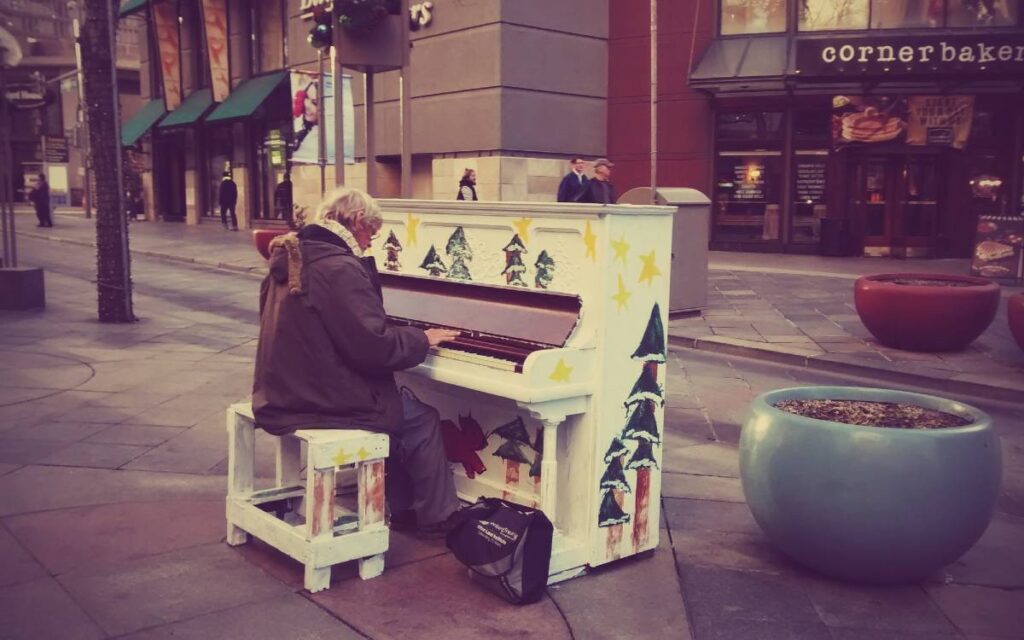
623,304,666,552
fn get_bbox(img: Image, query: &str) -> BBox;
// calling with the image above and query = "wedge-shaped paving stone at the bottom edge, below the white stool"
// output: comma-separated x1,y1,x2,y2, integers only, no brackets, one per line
118,594,366,640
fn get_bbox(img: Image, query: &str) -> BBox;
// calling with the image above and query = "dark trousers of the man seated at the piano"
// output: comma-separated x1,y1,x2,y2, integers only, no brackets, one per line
384,394,459,525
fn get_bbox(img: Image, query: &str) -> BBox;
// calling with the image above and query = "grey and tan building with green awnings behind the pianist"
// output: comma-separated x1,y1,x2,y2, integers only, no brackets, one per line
122,0,608,228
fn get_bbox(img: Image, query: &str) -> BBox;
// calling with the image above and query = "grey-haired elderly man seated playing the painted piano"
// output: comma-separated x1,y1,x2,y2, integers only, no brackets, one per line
253,188,459,537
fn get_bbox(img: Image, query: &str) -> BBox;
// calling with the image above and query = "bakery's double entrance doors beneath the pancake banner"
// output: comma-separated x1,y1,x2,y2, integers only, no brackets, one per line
851,151,944,258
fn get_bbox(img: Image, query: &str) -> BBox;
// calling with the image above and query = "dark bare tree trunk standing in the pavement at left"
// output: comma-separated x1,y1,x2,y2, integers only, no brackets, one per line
81,0,135,323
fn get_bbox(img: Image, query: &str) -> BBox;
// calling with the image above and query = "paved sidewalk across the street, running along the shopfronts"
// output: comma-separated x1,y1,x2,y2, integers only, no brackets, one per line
18,210,1024,401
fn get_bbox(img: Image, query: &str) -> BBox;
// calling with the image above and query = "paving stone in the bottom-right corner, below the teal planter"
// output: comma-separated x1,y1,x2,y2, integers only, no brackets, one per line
927,585,1024,638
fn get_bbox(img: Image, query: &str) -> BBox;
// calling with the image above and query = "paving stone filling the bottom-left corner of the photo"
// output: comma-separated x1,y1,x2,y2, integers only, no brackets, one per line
0,578,105,640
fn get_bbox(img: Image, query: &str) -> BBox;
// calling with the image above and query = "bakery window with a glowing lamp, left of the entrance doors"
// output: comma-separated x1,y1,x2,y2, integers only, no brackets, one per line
714,151,782,242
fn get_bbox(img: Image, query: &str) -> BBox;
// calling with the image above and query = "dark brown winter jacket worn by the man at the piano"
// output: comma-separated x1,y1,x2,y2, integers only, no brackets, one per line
253,225,429,435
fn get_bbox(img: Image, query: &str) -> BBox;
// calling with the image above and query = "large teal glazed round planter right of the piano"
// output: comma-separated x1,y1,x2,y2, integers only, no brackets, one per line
739,386,1002,583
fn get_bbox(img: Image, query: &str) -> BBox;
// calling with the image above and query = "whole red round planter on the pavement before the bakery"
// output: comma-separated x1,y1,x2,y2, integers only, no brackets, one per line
853,273,999,351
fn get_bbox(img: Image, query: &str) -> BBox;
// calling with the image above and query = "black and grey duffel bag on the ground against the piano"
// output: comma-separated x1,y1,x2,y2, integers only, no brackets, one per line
445,498,554,604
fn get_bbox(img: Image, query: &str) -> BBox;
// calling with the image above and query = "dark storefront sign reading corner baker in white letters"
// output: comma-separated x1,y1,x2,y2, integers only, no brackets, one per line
796,34,1024,77
